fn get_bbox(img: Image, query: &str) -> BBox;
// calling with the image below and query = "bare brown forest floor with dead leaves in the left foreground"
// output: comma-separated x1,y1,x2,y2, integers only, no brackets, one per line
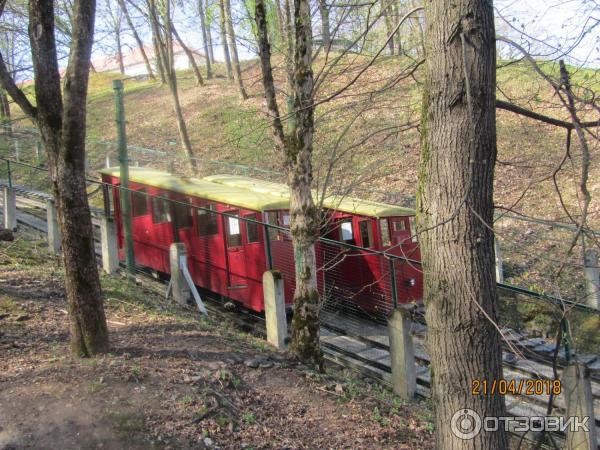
0,230,434,450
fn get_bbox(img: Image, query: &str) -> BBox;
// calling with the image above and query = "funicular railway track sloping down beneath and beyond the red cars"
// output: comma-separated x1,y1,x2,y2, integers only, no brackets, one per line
0,188,600,449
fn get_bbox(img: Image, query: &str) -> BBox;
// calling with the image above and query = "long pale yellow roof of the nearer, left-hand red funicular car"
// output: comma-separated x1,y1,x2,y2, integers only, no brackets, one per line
100,167,289,211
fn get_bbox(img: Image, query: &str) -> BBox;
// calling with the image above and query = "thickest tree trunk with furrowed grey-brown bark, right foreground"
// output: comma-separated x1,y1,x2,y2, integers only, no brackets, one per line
418,0,507,450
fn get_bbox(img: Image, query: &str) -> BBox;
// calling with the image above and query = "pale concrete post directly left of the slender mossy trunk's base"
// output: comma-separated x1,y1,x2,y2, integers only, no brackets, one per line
263,270,287,350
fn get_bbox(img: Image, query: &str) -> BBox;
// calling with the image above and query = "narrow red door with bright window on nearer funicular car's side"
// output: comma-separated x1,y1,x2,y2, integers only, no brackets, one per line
223,210,246,288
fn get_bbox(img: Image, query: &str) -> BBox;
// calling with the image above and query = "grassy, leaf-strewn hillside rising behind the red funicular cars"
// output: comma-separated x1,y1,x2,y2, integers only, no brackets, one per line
4,55,600,302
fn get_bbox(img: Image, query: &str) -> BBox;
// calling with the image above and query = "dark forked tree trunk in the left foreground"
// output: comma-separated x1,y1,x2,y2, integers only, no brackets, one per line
13,0,109,356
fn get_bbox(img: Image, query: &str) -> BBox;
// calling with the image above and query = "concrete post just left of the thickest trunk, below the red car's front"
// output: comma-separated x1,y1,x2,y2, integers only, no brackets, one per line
388,305,417,400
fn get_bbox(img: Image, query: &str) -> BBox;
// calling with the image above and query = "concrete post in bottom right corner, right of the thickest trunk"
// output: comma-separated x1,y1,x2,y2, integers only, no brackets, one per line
561,364,598,450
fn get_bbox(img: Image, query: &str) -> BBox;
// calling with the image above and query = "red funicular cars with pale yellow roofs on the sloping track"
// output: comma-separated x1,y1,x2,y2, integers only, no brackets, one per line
101,167,422,312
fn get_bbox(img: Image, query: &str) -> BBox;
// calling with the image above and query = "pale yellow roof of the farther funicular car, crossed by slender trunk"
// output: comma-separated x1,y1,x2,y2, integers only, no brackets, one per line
203,175,415,218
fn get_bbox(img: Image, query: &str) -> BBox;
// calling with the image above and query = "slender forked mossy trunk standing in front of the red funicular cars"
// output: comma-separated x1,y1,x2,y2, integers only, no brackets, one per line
255,0,323,368
